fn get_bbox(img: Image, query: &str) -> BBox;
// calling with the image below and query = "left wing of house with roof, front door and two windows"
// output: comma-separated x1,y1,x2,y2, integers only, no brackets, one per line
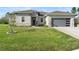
9,10,46,26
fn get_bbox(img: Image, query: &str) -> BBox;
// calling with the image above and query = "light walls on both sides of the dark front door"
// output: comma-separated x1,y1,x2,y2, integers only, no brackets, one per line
12,14,45,26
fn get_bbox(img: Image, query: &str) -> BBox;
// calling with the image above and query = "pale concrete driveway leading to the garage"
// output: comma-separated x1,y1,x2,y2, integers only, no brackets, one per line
54,27,79,39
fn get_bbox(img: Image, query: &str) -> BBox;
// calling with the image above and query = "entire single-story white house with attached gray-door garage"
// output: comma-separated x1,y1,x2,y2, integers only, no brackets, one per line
9,10,76,27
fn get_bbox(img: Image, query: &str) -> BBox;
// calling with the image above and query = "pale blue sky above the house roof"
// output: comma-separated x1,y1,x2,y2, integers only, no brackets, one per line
0,7,71,18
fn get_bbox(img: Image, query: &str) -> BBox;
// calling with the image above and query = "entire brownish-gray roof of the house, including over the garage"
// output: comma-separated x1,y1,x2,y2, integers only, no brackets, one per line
10,10,76,16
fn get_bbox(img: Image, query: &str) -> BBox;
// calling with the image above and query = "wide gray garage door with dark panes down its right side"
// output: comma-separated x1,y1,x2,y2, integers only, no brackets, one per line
52,18,70,27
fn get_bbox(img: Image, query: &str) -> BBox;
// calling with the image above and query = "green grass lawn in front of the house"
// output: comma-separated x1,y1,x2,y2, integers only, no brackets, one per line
0,24,79,51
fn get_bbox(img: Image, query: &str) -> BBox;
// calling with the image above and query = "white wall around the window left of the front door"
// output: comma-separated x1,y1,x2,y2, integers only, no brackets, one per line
15,14,31,26
